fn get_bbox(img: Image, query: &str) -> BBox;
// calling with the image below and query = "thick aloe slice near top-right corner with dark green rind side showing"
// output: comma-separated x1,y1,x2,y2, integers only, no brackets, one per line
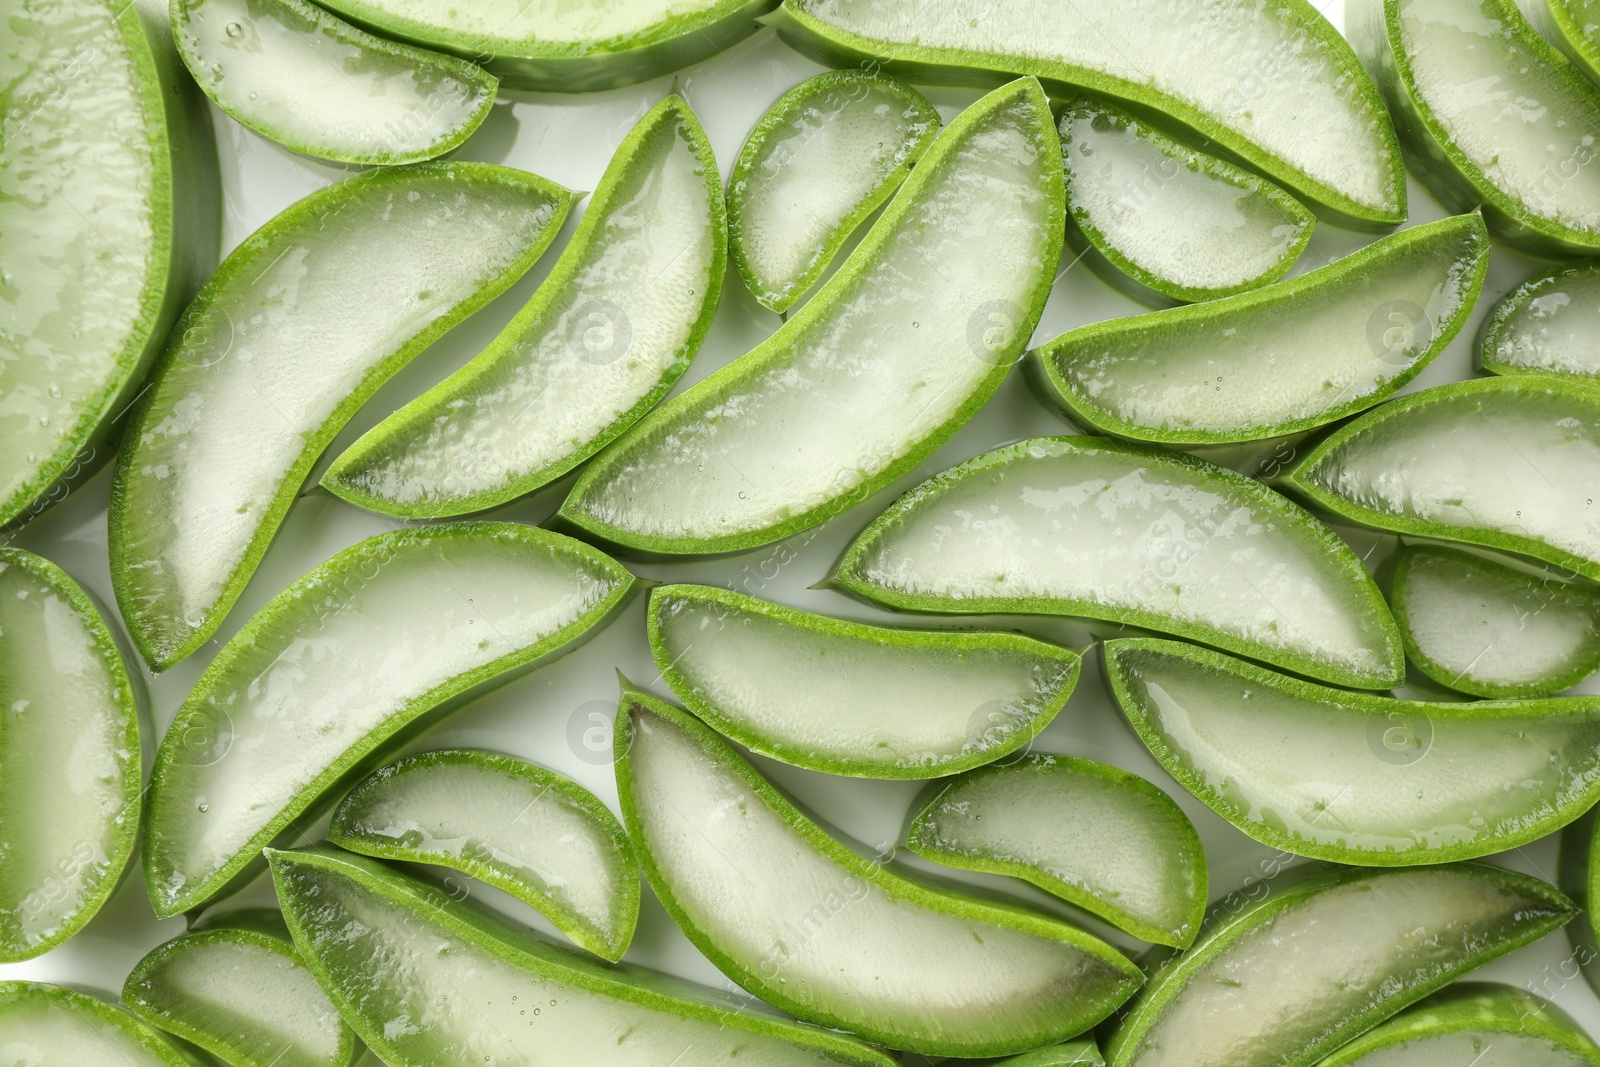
1346,0,1600,256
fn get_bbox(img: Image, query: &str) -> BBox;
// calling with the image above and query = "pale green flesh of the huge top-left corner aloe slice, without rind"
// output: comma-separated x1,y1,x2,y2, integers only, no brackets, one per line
0,0,159,522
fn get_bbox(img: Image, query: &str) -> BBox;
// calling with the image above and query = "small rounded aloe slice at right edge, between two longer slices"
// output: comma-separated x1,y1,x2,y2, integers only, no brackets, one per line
1389,545,1600,697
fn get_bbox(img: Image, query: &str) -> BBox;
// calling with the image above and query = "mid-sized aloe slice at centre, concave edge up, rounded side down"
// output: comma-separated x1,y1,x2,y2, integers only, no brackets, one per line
646,585,1078,779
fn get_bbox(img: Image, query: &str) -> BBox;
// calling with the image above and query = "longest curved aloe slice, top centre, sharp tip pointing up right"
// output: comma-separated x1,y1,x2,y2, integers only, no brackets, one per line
560,78,1066,553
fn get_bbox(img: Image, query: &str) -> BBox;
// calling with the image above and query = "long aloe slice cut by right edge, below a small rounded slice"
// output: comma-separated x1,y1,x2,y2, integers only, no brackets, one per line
1106,638,1600,867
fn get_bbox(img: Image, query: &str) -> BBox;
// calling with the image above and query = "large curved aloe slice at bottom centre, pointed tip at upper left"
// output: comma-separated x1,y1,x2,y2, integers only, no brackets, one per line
613,688,1141,1056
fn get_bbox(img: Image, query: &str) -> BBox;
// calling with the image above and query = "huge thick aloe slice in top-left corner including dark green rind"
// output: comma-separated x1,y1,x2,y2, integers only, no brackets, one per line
0,0,221,525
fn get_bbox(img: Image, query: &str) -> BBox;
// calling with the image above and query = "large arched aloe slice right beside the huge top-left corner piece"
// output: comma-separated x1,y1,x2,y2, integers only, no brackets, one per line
109,163,571,670
